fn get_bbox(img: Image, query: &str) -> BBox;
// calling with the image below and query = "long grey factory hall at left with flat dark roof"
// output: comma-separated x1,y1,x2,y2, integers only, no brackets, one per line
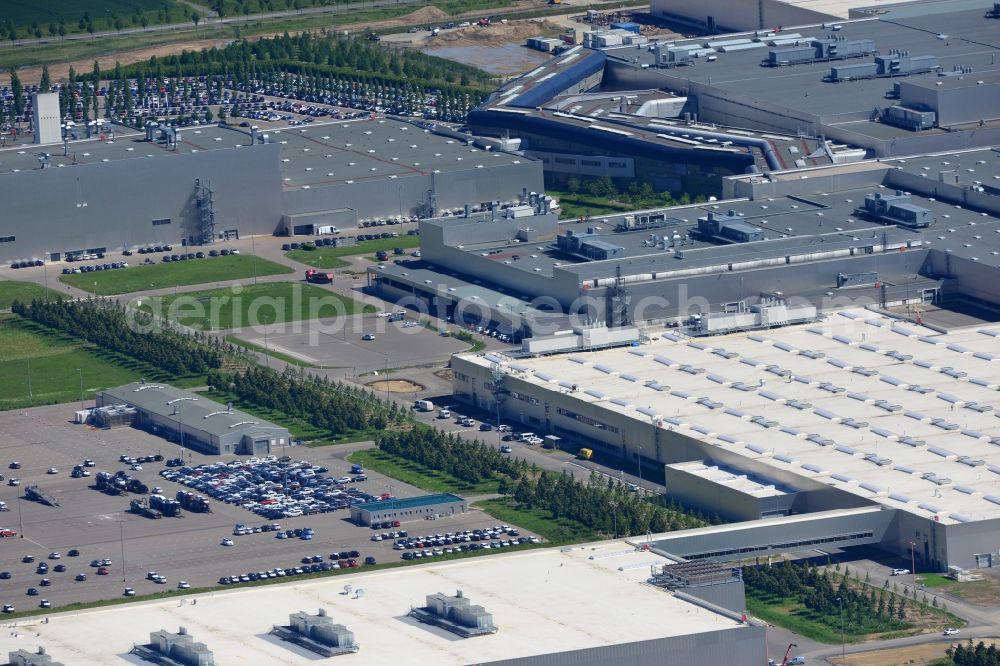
0,111,542,261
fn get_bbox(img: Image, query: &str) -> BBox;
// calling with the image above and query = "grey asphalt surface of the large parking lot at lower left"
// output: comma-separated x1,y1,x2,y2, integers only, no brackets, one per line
0,405,530,611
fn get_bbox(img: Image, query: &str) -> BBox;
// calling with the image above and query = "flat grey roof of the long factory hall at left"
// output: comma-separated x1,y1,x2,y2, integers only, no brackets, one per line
0,118,526,184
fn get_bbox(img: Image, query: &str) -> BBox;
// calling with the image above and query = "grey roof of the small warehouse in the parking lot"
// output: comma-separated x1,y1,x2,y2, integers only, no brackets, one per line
101,382,288,437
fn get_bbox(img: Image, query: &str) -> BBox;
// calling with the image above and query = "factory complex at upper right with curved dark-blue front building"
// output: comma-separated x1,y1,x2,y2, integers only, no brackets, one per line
469,0,1000,194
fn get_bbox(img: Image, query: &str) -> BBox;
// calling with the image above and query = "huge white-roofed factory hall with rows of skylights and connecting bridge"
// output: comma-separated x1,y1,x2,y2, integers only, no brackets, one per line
452,309,1000,570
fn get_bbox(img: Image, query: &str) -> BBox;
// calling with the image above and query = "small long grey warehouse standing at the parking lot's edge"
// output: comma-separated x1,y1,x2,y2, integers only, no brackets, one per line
97,382,292,455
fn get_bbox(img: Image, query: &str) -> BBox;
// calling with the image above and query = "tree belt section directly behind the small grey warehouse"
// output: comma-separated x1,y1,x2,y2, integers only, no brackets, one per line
206,366,407,436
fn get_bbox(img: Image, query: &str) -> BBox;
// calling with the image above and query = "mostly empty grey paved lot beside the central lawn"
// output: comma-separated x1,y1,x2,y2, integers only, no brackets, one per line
236,314,469,374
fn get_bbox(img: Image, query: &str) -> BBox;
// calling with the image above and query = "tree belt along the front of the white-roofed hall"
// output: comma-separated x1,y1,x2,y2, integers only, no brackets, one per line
377,429,708,536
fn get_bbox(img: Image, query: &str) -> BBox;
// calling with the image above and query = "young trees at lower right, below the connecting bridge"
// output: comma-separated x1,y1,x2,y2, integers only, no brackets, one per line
743,561,909,636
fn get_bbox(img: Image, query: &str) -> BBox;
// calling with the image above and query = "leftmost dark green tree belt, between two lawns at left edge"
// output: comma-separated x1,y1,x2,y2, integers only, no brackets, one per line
11,299,225,376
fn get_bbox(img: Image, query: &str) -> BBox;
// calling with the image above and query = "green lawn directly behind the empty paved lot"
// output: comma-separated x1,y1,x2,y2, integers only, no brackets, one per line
141,282,375,330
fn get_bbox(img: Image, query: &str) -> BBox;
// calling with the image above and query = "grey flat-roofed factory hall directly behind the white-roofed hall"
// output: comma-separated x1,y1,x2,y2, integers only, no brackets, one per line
369,143,1000,337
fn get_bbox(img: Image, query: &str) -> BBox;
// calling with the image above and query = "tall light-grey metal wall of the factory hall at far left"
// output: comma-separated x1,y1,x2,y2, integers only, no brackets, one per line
0,144,282,260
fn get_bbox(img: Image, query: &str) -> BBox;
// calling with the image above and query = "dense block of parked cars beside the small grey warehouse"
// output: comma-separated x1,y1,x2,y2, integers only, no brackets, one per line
160,456,388,520
